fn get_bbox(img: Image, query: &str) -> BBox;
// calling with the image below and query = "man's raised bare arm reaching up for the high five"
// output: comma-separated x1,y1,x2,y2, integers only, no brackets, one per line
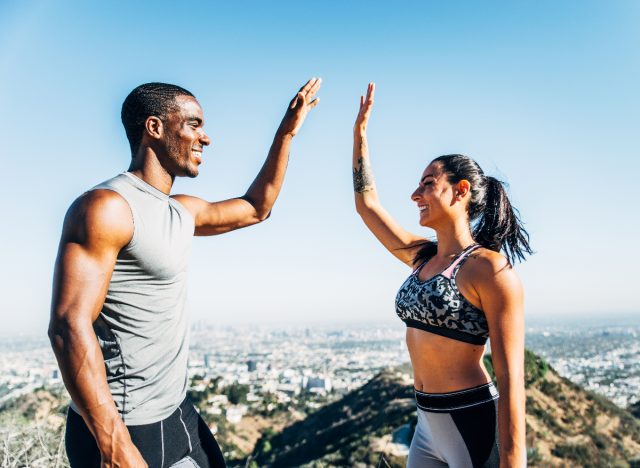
174,78,321,236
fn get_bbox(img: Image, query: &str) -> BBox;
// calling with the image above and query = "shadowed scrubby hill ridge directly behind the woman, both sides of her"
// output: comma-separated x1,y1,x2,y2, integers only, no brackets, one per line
253,352,640,467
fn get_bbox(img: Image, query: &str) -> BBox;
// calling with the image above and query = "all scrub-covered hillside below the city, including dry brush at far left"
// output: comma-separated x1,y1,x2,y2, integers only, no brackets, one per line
0,352,640,468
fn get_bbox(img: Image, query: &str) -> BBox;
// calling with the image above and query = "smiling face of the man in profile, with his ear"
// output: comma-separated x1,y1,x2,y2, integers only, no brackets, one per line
163,96,211,177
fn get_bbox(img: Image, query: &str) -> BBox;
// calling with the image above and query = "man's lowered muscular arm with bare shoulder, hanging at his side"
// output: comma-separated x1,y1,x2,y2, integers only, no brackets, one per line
49,190,146,467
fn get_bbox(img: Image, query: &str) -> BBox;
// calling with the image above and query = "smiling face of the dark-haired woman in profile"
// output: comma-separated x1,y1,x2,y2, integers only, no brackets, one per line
411,162,461,228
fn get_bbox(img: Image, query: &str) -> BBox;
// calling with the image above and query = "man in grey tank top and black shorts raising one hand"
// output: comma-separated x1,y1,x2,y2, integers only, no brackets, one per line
49,78,320,467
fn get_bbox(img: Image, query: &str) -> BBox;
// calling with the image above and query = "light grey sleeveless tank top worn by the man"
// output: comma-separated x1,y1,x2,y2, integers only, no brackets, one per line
70,172,195,425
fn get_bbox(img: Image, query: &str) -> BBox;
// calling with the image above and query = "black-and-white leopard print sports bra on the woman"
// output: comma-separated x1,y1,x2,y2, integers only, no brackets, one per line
396,244,489,345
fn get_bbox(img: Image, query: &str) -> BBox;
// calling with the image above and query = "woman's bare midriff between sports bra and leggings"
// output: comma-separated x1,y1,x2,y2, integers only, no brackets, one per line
407,328,491,393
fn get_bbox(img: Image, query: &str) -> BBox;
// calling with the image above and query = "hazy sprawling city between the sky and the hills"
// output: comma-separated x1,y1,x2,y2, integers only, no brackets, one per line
0,319,640,408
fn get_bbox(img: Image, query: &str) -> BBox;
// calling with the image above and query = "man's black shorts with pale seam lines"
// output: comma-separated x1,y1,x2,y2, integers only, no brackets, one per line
65,399,226,468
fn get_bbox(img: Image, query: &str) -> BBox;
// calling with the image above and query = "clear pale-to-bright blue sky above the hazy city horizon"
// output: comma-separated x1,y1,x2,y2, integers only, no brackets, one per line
0,0,640,331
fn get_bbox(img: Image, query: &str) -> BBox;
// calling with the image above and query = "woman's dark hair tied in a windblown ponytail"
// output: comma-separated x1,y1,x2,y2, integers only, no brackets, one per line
414,154,533,264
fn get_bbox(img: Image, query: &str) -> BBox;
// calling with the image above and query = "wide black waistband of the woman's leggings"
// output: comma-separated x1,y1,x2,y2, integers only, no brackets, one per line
414,382,499,413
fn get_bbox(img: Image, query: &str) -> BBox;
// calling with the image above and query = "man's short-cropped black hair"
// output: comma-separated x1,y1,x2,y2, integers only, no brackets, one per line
120,83,195,155
